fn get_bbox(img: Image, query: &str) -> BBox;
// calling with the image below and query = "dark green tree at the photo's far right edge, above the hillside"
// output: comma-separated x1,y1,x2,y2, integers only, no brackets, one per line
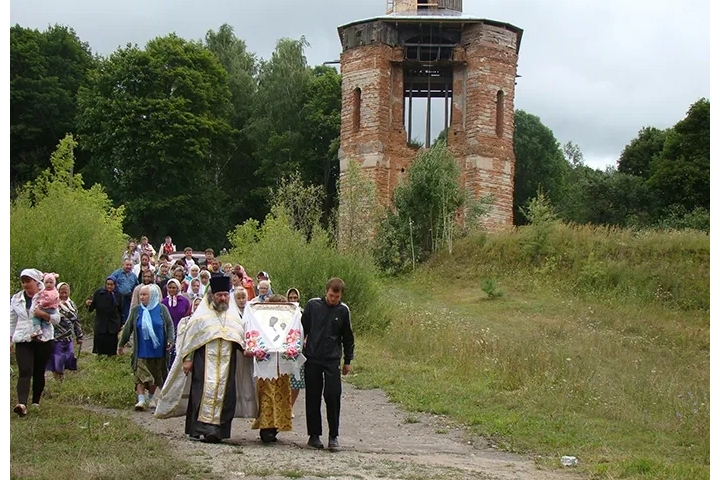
648,98,710,211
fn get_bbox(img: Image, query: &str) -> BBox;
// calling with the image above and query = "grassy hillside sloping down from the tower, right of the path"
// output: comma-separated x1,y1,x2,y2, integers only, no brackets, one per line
355,225,710,479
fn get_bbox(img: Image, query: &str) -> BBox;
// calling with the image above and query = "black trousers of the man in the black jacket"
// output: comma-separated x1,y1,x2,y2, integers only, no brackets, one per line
305,360,342,437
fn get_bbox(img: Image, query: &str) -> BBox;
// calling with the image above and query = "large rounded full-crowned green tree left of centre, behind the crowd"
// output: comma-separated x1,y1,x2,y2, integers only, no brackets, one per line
78,34,233,248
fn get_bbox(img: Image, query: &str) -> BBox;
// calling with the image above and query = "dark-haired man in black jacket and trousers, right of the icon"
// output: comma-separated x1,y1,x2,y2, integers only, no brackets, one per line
302,278,355,449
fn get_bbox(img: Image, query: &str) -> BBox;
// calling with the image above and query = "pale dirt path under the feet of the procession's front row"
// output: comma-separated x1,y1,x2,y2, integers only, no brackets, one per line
90,381,578,480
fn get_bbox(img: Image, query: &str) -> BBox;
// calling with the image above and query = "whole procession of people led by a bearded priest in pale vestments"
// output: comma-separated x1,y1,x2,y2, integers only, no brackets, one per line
10,237,354,449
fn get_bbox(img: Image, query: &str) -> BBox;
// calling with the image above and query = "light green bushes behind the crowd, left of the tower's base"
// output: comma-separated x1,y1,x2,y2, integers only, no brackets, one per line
228,209,389,332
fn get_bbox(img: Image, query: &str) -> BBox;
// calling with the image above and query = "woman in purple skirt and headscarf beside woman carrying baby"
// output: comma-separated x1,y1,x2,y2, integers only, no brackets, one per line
46,282,82,380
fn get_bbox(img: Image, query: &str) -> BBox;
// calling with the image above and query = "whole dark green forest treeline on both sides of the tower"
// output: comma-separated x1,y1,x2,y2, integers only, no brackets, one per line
10,24,710,249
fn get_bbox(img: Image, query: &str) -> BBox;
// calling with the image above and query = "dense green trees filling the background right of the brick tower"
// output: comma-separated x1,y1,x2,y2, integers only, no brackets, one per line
514,98,710,232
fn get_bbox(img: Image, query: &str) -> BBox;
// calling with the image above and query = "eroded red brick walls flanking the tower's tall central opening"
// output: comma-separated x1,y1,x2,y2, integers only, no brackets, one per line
339,15,521,235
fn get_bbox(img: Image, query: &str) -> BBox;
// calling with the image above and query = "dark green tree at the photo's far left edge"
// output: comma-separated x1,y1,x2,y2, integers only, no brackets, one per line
10,25,94,188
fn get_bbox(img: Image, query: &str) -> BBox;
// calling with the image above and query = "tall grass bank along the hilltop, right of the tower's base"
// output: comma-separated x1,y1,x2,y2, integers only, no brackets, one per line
428,223,710,310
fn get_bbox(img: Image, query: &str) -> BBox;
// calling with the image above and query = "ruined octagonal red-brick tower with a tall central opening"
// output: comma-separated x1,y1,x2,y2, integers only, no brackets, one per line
338,0,522,236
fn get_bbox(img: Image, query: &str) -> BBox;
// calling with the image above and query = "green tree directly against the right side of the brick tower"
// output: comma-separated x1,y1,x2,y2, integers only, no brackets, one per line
513,110,570,225
